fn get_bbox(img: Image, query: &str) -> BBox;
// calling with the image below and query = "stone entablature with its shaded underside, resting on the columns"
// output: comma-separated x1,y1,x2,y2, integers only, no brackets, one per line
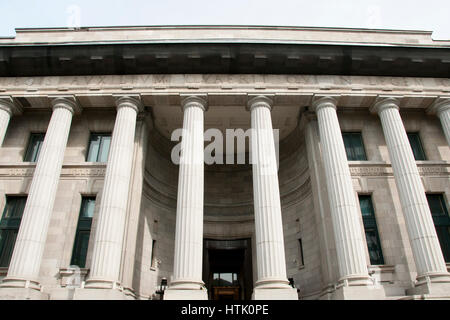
0,74,450,139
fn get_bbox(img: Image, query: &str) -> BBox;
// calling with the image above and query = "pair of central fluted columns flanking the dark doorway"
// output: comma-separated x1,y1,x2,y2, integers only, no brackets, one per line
164,96,298,300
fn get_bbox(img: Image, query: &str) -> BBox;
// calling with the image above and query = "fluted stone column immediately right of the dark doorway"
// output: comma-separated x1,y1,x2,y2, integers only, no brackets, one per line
248,96,298,300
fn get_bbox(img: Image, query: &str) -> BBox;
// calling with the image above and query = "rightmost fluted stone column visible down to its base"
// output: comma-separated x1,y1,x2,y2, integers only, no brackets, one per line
372,98,450,285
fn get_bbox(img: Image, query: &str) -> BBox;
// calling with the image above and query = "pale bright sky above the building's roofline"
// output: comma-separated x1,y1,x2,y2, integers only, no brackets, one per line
0,0,450,40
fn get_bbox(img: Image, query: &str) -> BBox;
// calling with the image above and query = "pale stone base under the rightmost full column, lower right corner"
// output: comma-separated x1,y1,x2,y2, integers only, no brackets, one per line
406,273,450,299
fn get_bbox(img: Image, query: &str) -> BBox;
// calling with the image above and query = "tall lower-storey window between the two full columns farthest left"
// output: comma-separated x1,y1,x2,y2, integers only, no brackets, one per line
70,197,95,268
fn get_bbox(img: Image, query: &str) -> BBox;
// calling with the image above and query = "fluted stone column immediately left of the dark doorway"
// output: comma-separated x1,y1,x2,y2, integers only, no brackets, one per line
164,97,208,300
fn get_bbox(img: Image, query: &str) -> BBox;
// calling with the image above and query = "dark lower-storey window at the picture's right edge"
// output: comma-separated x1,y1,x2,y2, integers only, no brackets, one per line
427,194,450,262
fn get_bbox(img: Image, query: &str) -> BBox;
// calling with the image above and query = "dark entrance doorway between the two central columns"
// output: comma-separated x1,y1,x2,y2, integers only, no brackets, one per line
203,239,253,300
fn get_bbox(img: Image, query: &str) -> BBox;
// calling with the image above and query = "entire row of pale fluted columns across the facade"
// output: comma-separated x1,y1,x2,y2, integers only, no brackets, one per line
0,96,450,299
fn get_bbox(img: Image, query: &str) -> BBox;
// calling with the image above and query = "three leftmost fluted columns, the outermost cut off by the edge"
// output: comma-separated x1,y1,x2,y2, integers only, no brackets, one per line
0,96,142,290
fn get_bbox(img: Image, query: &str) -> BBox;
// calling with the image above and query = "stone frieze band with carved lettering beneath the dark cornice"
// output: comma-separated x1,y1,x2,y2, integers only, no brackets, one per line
0,74,450,90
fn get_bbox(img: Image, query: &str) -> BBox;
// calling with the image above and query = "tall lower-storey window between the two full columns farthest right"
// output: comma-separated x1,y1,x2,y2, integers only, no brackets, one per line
358,195,384,265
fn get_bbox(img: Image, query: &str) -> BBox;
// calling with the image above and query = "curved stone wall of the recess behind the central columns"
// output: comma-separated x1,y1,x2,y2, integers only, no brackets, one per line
134,127,322,296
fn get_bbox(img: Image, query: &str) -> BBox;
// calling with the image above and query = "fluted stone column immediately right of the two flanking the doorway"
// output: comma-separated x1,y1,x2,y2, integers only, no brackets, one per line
313,97,371,286
